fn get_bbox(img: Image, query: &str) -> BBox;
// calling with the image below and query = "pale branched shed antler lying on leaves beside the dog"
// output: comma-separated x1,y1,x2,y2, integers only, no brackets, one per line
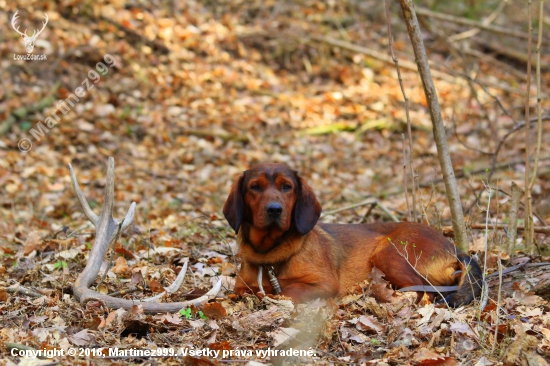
69,157,222,313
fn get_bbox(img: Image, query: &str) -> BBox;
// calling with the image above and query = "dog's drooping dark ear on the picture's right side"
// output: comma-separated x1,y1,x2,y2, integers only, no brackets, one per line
294,173,321,235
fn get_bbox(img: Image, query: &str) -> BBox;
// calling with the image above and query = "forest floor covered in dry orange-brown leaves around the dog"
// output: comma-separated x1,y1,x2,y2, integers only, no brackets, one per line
0,0,550,365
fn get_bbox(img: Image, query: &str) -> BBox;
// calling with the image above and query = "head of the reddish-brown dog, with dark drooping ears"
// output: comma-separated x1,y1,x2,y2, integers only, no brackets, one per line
223,163,321,235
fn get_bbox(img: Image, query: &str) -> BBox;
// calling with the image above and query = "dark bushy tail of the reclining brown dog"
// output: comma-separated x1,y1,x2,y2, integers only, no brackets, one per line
445,253,483,308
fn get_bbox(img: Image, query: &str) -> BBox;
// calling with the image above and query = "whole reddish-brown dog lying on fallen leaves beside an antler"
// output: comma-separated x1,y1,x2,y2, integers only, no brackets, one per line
223,163,481,306
